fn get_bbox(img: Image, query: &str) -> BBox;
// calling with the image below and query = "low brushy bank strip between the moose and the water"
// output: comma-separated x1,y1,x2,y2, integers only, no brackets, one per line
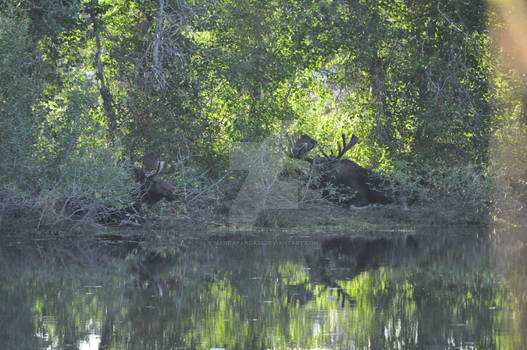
0,200,490,240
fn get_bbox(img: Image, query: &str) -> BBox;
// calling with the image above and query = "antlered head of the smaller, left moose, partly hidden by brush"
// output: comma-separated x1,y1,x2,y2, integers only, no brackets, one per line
133,151,175,205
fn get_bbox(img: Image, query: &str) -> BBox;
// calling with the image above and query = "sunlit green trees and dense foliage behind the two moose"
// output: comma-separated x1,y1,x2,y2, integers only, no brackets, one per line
0,0,527,220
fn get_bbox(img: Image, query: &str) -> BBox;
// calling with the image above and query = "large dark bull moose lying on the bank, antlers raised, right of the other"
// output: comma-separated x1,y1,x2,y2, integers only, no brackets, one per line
286,134,406,207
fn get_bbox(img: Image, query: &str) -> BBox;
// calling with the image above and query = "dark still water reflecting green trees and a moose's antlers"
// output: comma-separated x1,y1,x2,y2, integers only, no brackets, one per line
0,229,527,350
